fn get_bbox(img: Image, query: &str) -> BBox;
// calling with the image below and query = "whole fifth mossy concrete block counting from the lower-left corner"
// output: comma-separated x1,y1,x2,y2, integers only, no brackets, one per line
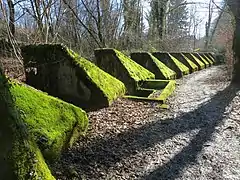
131,52,176,80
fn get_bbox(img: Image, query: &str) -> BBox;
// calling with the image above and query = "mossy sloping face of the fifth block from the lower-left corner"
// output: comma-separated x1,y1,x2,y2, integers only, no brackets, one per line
148,53,176,79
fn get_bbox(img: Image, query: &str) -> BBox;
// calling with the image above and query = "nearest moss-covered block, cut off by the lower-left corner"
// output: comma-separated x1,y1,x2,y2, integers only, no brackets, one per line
0,70,55,180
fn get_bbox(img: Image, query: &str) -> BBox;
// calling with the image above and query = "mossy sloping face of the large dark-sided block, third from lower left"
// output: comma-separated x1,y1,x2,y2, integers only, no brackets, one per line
66,48,126,104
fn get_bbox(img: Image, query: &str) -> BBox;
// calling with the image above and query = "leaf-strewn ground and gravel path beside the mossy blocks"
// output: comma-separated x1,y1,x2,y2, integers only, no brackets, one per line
53,66,240,180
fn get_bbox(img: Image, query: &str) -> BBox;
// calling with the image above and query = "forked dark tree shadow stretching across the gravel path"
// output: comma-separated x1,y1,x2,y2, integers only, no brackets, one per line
55,83,239,179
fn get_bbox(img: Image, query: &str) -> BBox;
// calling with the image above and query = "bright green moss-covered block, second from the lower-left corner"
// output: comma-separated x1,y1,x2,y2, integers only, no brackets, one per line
10,82,88,160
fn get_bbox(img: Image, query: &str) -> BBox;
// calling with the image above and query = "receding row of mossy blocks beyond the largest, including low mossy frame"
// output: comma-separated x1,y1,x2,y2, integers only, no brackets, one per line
95,49,216,103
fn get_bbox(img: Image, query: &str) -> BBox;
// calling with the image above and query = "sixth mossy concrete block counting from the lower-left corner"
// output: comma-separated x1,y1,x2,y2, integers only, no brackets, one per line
152,52,189,78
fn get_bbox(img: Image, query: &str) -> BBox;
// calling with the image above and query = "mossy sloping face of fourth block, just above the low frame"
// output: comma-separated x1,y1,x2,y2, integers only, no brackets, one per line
114,50,155,82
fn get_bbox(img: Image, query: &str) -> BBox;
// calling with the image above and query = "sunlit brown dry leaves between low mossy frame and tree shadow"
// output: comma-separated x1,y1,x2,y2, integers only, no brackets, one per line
88,99,159,137
